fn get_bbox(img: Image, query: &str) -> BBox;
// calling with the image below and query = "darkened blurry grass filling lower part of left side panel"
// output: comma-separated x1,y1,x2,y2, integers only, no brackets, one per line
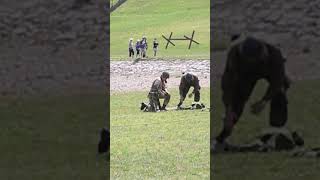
0,95,108,180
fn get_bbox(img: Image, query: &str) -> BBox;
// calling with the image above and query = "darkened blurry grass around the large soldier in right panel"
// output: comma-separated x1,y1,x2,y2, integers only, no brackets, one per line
211,80,320,180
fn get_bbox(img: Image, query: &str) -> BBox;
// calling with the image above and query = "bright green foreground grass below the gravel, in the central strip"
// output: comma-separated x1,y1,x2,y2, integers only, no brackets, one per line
110,88,210,179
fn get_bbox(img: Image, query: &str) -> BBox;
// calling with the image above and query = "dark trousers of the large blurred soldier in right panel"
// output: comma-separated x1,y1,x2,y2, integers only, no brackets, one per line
216,78,288,142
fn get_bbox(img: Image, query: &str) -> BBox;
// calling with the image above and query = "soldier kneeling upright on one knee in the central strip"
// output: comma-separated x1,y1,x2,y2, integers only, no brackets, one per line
141,72,170,112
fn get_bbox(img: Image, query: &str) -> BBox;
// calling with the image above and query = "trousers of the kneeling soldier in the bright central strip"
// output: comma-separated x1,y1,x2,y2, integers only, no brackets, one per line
148,93,171,112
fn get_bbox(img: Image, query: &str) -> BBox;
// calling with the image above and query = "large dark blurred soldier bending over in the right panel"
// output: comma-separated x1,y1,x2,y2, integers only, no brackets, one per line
212,37,290,151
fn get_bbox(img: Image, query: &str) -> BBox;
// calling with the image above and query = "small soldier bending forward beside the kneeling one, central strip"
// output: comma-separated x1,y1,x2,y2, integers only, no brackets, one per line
178,73,200,109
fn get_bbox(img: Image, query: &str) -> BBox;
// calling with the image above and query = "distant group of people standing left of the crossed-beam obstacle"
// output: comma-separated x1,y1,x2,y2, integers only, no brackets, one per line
129,36,159,58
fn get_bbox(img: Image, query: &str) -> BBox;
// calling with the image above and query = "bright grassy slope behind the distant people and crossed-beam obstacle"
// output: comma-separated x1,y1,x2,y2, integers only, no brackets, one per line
110,0,210,60
